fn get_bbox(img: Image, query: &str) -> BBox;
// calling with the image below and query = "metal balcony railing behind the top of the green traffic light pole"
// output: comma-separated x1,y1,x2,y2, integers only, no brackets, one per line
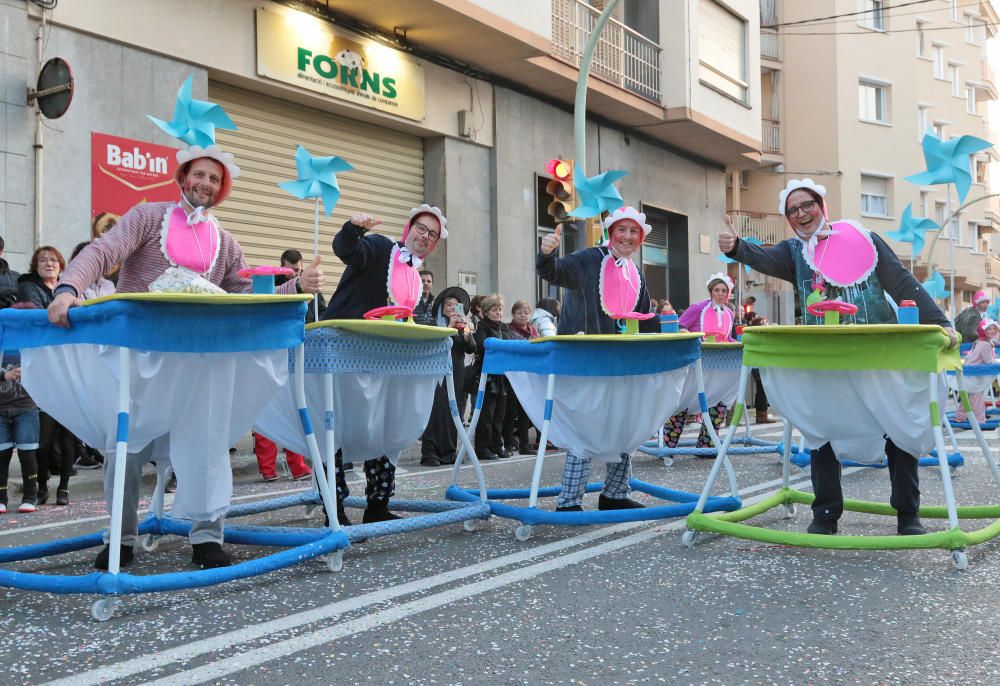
552,0,661,103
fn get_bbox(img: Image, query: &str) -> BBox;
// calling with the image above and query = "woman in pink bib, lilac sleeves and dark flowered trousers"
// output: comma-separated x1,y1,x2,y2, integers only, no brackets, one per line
663,273,734,448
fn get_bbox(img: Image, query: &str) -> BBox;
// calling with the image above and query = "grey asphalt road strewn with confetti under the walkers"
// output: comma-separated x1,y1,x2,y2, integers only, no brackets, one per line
0,426,1000,686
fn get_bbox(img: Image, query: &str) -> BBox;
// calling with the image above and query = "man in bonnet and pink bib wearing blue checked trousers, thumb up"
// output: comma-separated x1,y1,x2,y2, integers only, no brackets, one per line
535,207,660,512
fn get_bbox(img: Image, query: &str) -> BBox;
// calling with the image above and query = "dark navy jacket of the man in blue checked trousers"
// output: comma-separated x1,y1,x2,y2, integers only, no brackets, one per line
535,248,660,334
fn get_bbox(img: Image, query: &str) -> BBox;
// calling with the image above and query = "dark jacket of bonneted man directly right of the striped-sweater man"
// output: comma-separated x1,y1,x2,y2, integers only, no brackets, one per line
320,221,402,319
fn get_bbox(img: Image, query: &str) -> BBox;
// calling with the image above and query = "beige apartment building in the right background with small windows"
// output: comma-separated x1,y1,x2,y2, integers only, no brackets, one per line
727,0,1000,322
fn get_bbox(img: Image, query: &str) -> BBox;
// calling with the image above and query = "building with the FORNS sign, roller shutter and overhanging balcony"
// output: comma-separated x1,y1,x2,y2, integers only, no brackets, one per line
0,0,762,306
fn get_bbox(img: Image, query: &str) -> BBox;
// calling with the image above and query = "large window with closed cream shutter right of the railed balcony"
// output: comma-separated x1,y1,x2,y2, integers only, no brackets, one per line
698,0,749,102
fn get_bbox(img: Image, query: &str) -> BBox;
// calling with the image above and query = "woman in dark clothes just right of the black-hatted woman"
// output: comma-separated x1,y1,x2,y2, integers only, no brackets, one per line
473,293,510,460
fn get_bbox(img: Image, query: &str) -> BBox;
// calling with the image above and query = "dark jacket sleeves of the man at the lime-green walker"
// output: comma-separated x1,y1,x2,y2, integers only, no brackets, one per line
726,232,951,327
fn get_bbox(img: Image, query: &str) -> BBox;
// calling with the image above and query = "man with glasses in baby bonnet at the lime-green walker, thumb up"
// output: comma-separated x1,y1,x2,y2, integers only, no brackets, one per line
719,179,958,535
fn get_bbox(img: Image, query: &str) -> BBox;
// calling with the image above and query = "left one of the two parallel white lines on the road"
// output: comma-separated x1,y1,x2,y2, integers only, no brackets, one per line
41,467,828,686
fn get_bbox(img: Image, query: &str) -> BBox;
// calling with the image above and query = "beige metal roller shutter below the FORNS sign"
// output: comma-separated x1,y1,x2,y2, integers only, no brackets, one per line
208,81,424,295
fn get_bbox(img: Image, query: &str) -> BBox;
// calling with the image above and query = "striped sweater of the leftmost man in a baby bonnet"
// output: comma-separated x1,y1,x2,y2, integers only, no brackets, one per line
59,202,297,293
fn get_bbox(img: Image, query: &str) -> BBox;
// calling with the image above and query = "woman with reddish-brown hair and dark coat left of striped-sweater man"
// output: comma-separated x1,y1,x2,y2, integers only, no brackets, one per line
17,245,76,505
